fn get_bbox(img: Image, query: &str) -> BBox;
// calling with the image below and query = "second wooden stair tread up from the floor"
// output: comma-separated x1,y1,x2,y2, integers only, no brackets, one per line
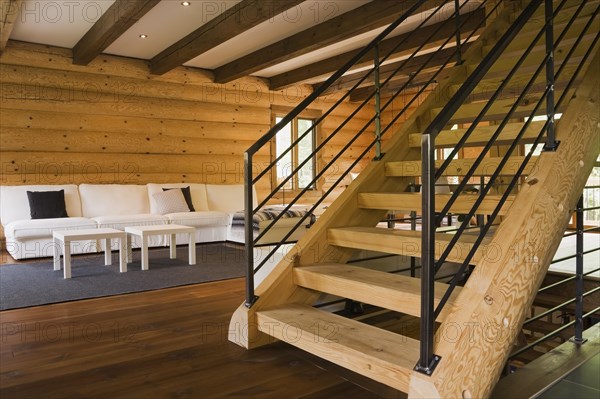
294,263,462,322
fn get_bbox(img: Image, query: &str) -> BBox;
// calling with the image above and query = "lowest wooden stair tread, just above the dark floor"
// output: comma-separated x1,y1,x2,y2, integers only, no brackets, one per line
256,304,419,392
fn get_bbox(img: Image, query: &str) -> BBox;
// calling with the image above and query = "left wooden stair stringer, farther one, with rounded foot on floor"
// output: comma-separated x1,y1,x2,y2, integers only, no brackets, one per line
229,0,519,349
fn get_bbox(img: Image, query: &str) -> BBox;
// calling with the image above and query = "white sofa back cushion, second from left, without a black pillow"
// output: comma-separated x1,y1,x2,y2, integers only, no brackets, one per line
79,184,150,218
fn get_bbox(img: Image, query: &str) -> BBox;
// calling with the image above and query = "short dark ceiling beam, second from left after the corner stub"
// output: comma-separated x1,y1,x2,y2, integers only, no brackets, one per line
73,0,160,65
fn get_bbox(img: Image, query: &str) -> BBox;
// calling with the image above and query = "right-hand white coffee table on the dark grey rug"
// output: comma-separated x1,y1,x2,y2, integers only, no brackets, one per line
125,224,196,270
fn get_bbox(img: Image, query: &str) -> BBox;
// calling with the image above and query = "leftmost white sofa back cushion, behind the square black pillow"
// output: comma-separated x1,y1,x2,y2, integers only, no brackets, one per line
0,184,81,226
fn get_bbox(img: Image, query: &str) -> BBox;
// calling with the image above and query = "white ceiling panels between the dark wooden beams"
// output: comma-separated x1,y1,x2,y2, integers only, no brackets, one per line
4,0,479,83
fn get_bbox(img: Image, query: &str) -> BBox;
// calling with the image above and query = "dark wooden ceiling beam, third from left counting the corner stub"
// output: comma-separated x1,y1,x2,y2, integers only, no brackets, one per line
150,0,304,75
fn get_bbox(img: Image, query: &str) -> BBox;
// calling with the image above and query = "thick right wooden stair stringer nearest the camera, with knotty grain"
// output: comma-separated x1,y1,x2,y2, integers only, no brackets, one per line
409,46,600,397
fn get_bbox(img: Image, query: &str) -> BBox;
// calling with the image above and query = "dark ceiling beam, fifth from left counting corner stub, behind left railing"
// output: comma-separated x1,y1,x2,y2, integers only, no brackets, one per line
269,10,485,90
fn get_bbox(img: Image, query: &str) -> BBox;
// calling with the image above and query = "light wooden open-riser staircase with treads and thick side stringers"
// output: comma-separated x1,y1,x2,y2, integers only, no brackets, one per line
230,0,600,398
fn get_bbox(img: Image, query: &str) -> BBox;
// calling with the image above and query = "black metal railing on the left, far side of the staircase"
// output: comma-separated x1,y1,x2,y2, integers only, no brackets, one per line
244,0,499,307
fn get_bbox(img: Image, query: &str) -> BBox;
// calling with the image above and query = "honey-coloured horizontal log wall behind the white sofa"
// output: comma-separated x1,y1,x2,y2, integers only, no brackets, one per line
0,41,394,203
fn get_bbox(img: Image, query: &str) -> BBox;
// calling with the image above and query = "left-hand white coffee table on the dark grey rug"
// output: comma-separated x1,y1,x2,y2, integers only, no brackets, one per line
52,229,127,278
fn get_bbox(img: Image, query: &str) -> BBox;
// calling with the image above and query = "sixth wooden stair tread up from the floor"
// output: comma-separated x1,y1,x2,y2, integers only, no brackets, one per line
408,121,546,148
